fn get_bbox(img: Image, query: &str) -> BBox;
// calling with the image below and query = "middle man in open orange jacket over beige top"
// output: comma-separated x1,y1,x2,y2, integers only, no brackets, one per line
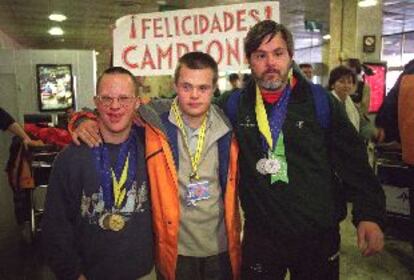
70,52,240,280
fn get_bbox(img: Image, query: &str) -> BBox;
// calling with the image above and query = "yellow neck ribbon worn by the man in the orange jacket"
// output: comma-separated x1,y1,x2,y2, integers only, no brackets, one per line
171,99,207,180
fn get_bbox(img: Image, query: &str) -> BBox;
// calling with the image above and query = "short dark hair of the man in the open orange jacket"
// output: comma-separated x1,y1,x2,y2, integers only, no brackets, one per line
174,52,218,85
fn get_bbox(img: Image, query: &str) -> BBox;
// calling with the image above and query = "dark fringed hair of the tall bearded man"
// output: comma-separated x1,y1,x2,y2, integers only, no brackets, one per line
244,20,294,59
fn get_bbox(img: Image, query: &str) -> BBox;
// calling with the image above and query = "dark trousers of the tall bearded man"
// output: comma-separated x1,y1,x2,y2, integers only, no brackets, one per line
242,225,340,280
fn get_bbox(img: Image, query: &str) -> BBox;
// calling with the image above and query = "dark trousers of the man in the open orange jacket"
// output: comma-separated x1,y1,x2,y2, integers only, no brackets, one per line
175,252,232,280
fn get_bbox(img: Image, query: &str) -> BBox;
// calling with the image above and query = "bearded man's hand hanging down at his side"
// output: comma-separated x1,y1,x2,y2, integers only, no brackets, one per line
357,221,384,256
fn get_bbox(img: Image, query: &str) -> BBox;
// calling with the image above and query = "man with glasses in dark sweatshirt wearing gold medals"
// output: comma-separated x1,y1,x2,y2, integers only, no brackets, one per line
42,67,154,280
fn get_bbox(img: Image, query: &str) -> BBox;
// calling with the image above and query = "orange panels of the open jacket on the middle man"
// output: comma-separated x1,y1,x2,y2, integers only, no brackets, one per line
142,106,241,280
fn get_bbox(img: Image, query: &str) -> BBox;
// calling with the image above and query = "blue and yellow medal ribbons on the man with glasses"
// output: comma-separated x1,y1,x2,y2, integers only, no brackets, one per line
93,127,137,211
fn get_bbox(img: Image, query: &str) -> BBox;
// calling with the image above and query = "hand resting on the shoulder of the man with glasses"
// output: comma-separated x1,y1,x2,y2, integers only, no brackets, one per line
72,120,102,148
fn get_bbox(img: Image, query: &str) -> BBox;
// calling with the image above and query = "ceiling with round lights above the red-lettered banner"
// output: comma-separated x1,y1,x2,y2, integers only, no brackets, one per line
0,0,414,68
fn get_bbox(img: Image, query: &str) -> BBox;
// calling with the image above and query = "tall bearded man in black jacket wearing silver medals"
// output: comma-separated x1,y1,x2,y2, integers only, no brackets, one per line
221,20,385,280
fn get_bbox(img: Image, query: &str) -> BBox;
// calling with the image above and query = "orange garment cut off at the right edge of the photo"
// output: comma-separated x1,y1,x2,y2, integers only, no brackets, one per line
398,74,414,165
